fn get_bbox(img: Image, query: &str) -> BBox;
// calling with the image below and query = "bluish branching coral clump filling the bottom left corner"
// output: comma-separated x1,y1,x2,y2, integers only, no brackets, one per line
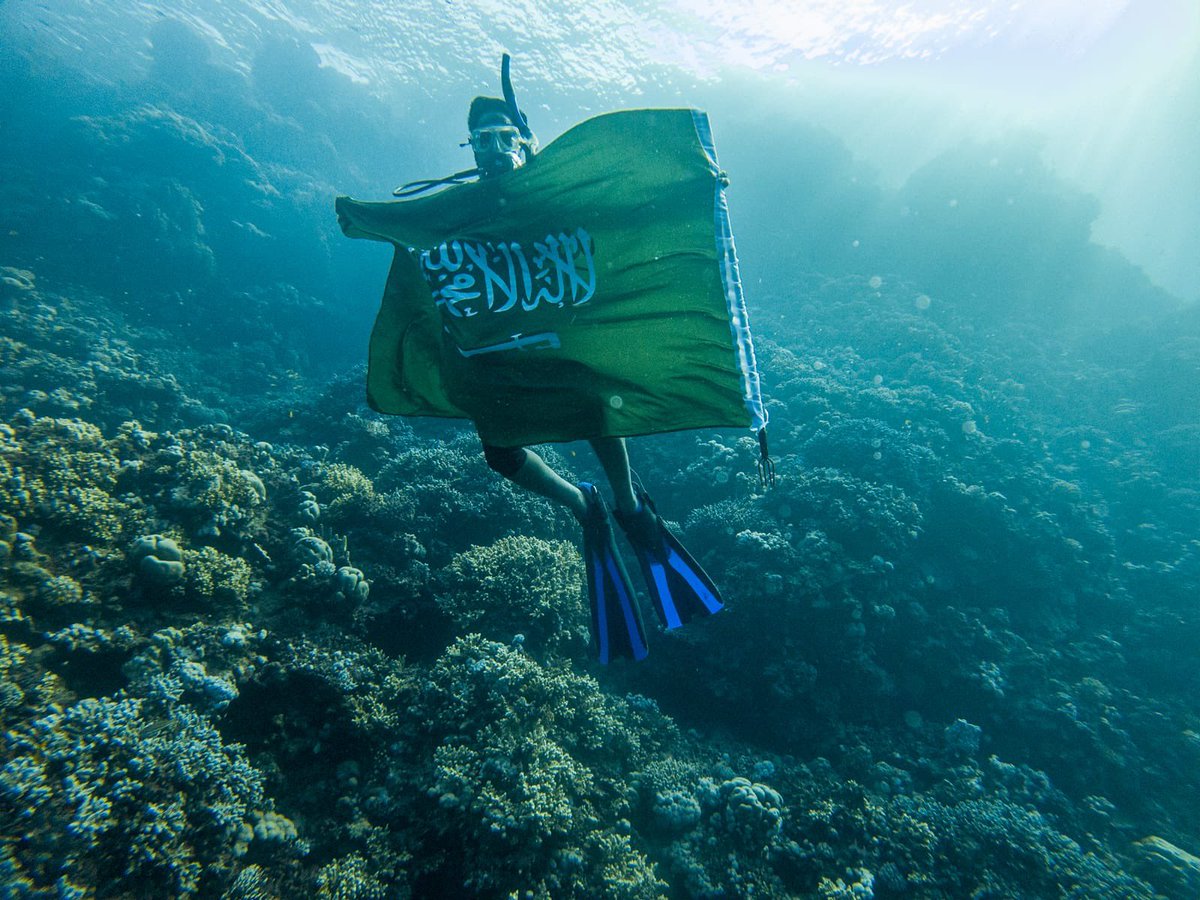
0,700,292,896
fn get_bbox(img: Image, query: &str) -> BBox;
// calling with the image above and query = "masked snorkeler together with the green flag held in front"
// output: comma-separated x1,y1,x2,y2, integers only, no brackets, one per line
336,55,773,662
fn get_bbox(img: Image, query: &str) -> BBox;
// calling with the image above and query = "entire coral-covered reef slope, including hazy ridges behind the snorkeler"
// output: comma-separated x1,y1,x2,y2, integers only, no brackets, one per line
0,14,1200,900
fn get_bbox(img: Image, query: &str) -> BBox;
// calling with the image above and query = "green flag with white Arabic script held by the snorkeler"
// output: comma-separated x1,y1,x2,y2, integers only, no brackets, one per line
337,109,766,446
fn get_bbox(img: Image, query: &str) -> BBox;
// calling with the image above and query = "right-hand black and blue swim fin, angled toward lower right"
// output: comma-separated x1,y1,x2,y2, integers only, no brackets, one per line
613,487,725,629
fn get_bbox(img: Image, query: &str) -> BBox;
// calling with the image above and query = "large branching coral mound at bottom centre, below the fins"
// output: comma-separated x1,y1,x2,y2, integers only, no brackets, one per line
396,636,670,898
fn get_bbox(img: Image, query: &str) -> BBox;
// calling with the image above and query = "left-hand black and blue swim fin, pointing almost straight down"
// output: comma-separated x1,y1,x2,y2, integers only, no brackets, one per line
580,481,649,664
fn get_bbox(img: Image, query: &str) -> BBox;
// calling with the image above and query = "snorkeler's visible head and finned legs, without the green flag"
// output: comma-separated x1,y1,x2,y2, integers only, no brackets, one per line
460,54,722,662
